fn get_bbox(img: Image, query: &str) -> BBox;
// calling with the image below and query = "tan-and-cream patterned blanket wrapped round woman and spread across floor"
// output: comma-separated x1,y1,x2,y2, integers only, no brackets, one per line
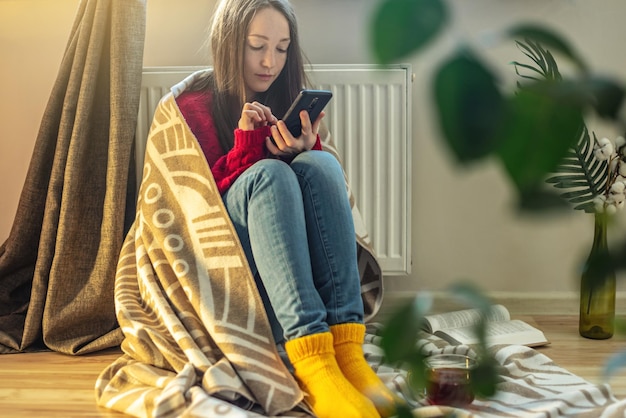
96,73,626,418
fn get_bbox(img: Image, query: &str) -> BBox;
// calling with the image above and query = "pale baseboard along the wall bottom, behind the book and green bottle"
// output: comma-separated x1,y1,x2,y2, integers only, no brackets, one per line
380,291,626,316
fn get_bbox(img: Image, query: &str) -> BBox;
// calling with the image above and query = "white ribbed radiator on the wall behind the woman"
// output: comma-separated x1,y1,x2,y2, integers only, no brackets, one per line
135,64,411,275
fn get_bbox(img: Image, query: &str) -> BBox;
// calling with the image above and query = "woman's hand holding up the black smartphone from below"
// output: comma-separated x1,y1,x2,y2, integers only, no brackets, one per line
265,110,325,157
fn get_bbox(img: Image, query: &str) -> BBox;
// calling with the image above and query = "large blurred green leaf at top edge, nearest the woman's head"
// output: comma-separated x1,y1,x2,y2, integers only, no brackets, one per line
371,0,448,64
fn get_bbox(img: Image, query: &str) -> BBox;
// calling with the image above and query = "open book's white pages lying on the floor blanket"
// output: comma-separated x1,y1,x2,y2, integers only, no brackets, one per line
435,319,548,347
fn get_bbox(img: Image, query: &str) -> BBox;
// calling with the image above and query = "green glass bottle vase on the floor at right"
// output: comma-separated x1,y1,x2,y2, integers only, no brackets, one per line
578,214,615,340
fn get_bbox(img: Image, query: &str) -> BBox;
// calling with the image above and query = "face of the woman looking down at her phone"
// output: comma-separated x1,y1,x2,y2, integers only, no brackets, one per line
243,7,290,100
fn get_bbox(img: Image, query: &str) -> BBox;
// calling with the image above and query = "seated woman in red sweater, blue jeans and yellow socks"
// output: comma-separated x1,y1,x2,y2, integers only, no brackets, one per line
177,0,394,417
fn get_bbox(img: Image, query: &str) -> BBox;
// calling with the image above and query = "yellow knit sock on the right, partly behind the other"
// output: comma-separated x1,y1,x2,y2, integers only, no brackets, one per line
330,323,401,417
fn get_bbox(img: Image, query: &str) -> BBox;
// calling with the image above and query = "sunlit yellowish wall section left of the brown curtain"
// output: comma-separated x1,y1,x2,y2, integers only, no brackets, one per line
0,0,78,247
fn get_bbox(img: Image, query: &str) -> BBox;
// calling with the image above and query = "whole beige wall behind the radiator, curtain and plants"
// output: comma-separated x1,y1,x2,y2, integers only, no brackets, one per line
0,0,626,298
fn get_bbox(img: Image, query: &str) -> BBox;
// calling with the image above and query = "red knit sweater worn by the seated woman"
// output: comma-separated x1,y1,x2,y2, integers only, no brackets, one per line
176,91,322,194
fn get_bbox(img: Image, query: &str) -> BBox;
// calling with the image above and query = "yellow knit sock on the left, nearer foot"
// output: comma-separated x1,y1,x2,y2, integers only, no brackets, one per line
285,332,380,418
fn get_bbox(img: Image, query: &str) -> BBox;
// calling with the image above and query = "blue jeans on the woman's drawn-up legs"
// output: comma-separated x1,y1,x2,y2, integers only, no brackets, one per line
223,151,363,343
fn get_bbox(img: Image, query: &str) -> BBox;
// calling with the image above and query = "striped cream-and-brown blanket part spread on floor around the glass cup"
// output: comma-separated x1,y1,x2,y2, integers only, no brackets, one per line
364,324,626,418
